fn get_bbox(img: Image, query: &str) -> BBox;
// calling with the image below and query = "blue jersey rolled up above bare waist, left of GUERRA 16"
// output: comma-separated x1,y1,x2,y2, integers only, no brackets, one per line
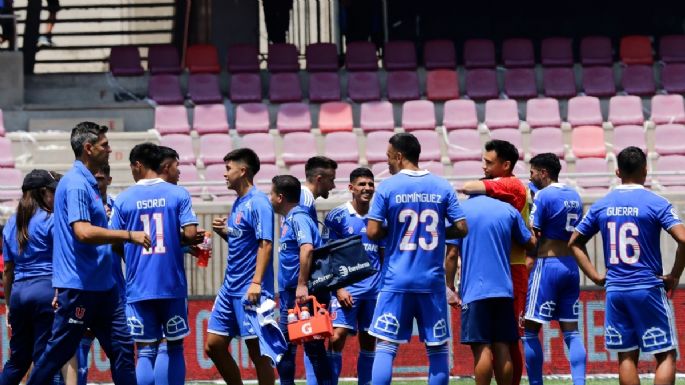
530,183,583,242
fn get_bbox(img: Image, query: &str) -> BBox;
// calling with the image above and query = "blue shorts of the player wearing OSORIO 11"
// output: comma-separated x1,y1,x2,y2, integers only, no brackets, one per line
126,298,190,342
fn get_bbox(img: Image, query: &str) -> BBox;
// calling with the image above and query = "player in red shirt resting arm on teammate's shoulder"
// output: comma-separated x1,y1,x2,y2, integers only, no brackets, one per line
460,140,529,385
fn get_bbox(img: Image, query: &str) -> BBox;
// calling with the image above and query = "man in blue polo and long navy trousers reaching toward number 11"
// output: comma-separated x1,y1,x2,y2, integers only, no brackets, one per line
27,122,150,385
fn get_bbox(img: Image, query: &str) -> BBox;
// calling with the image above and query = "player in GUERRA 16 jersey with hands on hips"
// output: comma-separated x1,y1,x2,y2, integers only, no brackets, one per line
569,146,685,385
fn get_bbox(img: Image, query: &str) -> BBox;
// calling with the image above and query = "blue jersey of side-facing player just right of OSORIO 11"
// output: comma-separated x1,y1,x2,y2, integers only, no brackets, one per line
224,187,274,296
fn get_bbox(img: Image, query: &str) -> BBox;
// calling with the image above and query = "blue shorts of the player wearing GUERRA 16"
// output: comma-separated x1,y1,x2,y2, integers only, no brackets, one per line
604,286,678,354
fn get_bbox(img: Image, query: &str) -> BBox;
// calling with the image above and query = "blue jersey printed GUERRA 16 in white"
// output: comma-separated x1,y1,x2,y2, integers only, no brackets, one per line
576,185,682,291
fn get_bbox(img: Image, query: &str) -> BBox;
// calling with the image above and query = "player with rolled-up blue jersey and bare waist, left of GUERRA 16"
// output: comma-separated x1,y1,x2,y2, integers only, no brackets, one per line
523,153,586,385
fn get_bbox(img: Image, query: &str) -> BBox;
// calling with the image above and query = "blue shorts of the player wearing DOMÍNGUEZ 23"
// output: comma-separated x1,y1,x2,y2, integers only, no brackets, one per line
369,289,450,345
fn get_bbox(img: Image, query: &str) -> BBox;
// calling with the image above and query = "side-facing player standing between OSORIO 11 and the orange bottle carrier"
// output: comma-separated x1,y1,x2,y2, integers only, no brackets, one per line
205,148,276,385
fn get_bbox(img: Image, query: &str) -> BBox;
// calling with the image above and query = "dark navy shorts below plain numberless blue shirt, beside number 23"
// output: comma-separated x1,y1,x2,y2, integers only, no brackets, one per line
461,297,519,345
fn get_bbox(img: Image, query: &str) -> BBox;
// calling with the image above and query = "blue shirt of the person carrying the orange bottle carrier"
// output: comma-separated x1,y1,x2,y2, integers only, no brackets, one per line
278,206,322,291
